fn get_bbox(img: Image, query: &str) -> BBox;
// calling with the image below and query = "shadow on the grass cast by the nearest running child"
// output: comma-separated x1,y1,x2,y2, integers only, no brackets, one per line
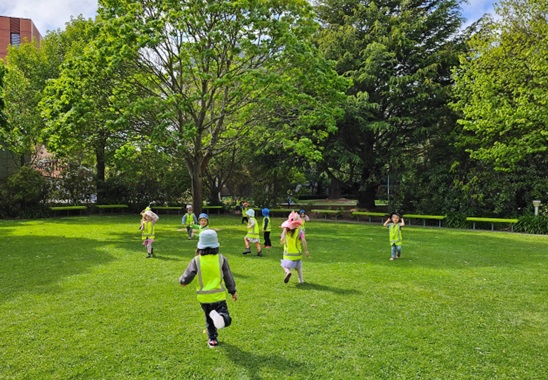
219,342,308,380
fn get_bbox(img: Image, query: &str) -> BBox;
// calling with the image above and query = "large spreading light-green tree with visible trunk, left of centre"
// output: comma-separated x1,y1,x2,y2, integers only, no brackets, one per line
85,0,344,214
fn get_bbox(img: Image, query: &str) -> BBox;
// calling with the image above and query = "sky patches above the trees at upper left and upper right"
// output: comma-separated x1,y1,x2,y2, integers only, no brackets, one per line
0,0,498,36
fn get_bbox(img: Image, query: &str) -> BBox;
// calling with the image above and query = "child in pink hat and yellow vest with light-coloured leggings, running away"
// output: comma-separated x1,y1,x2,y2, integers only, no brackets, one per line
280,211,310,284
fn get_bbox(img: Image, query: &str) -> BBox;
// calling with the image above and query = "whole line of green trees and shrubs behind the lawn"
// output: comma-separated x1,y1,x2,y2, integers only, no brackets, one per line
0,0,548,223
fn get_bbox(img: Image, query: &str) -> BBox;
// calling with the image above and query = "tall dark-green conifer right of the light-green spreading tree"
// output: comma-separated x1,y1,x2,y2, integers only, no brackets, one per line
316,0,462,209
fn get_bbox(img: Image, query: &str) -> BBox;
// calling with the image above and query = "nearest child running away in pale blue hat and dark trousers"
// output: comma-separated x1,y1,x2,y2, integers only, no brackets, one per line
179,230,237,348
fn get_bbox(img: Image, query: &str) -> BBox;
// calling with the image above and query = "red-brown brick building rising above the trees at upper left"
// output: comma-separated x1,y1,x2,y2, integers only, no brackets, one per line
0,16,42,59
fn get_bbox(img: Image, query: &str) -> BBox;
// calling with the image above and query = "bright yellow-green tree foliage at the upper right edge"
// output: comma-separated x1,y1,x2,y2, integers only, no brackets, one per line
453,0,548,173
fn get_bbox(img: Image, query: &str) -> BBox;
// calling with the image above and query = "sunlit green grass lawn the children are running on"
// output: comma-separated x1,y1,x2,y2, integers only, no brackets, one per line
0,215,548,379
